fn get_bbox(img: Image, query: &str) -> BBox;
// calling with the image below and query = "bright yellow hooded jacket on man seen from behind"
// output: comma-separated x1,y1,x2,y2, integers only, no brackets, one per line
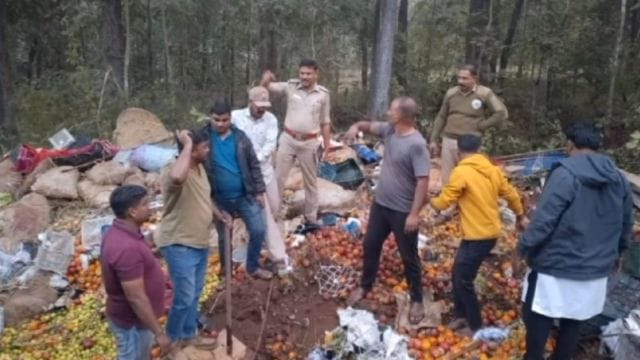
431,154,523,240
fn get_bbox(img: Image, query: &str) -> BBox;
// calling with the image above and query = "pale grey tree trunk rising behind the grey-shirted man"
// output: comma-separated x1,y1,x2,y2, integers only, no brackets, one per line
368,0,398,119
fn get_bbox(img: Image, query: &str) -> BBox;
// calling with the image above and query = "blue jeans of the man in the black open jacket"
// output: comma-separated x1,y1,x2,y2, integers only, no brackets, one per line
216,196,266,273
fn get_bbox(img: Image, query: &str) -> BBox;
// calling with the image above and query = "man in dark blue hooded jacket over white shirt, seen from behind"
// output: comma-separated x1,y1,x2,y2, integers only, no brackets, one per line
518,123,633,360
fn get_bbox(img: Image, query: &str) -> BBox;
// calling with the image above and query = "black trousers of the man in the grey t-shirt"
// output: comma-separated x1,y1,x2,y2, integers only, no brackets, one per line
361,202,422,302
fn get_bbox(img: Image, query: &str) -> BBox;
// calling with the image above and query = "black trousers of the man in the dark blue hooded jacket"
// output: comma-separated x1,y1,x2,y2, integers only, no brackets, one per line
522,271,582,360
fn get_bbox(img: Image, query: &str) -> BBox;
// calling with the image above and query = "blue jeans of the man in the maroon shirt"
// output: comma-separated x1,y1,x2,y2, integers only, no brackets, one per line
109,320,154,360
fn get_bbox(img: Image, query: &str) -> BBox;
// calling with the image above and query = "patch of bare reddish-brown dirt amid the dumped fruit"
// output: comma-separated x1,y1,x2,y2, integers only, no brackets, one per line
203,272,338,359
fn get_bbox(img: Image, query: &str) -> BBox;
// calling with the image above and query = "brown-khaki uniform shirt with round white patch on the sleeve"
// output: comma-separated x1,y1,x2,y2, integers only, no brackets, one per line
431,85,509,143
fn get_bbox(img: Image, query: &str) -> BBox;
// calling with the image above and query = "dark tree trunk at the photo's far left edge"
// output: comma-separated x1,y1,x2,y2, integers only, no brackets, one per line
0,0,14,133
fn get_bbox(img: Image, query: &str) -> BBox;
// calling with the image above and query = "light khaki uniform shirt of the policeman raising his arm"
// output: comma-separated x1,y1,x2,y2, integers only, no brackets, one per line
269,79,331,134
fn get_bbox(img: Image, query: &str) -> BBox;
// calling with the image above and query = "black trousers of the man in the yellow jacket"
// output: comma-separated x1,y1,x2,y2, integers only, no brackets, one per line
452,239,496,331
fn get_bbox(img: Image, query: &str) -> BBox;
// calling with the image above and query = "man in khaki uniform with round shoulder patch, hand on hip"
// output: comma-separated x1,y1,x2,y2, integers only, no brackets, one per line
429,65,508,186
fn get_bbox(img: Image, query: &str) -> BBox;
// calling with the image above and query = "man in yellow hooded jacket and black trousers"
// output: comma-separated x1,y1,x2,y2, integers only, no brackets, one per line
431,135,524,335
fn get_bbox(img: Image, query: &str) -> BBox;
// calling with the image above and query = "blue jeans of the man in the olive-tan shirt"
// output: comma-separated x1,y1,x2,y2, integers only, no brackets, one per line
160,245,209,341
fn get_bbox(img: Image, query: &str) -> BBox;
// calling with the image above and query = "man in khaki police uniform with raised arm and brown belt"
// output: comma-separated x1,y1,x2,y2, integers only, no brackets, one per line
260,59,331,223
